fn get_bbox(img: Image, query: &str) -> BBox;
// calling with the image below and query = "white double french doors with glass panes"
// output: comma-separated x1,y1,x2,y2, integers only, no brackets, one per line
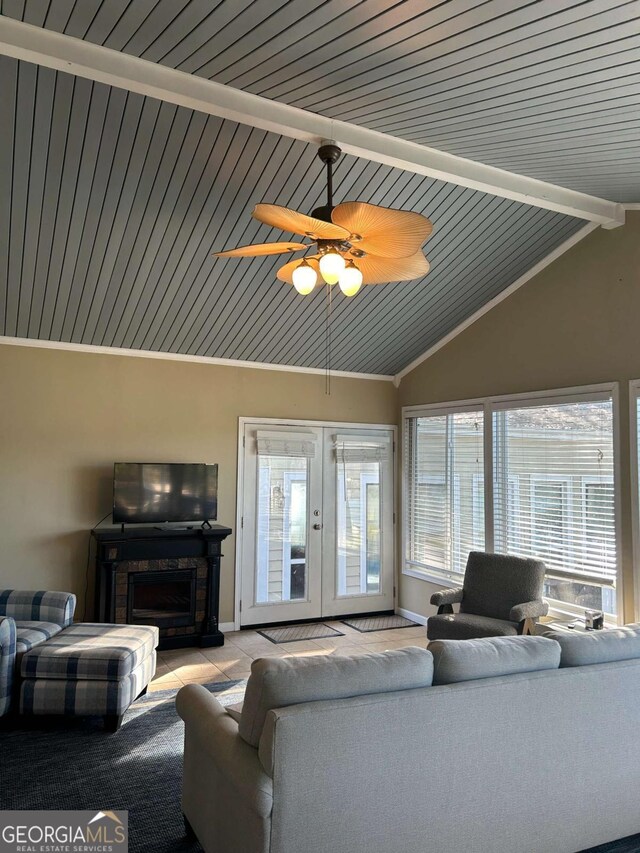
239,421,394,627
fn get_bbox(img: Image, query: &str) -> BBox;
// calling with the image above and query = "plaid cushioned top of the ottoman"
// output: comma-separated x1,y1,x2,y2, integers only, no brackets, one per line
21,622,159,681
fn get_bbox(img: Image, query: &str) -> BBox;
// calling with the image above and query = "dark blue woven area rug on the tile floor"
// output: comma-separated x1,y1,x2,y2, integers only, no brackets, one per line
0,681,640,853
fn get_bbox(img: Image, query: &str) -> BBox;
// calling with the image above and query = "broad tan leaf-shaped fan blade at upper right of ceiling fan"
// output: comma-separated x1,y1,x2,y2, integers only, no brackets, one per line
331,201,433,258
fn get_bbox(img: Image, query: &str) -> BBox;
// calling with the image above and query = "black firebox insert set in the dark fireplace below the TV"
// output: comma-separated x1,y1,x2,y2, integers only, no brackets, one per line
128,569,196,628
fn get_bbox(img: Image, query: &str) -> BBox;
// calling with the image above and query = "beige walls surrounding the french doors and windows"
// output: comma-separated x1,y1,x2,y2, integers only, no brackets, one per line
5,213,640,621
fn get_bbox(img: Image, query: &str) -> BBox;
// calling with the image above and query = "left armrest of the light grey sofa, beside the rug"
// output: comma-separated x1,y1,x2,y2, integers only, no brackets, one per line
176,684,273,818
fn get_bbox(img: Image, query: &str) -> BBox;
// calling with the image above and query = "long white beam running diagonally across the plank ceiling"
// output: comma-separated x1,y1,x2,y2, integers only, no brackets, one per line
0,15,624,228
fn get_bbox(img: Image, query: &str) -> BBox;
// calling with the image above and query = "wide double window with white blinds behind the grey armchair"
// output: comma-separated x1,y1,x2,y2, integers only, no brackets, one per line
404,389,618,615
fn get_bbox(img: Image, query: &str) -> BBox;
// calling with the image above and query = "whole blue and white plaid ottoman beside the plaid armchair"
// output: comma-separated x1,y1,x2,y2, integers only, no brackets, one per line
20,622,159,731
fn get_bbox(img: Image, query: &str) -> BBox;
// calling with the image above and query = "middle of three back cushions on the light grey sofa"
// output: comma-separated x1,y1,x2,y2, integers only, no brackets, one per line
429,637,560,684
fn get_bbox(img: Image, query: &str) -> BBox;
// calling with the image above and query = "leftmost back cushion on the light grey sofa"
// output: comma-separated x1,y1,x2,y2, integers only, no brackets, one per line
238,647,433,747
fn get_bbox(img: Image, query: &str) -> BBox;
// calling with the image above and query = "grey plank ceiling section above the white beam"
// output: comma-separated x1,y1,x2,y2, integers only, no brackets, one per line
2,0,640,202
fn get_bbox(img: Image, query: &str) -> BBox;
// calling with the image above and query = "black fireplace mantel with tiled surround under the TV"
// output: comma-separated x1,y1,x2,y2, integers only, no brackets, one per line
91,524,232,649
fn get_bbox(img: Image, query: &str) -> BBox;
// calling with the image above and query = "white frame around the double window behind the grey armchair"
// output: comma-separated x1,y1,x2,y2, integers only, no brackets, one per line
400,379,624,624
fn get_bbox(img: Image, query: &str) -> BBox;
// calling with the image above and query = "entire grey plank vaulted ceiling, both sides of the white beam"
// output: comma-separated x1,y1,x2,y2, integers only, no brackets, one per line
0,0,640,375
